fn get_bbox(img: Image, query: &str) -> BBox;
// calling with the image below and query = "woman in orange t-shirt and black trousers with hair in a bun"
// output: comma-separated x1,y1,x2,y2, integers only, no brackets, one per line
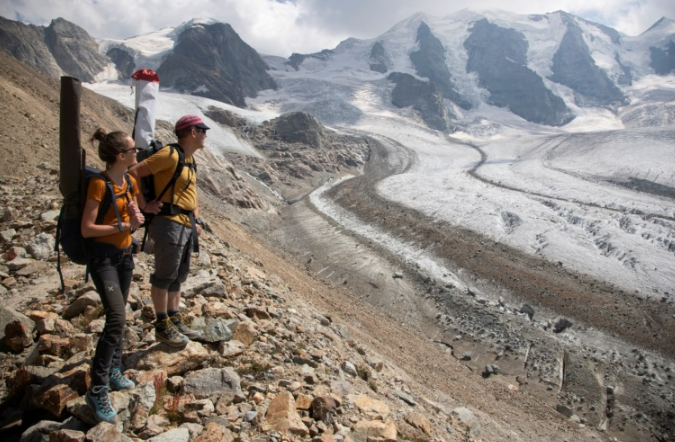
82,128,143,423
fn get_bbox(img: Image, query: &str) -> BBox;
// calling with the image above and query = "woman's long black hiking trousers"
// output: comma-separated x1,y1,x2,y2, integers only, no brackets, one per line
89,253,134,386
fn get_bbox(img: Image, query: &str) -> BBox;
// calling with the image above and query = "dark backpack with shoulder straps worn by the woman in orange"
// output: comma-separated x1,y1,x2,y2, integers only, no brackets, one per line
54,167,134,291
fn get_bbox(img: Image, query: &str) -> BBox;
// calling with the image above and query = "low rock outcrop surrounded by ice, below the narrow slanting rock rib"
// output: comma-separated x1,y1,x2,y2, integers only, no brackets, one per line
387,72,449,130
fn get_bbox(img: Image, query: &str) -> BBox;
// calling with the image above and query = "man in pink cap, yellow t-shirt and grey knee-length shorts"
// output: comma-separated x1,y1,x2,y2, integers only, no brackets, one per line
129,115,209,347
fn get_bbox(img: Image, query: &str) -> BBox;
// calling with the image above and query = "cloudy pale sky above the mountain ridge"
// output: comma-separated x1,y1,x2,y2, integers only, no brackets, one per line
0,0,675,57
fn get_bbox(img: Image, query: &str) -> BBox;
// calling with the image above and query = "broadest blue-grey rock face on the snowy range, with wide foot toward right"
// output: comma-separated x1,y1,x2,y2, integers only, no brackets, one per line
464,19,572,126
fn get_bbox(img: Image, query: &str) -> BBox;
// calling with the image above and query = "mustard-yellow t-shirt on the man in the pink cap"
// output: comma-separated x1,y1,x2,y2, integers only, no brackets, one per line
143,146,197,227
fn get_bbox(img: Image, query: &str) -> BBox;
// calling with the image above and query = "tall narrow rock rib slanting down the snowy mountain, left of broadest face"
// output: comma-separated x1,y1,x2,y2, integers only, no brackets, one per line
410,22,471,109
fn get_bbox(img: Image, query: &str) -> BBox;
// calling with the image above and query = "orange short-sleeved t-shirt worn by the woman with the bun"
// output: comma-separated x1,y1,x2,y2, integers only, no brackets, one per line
87,172,139,249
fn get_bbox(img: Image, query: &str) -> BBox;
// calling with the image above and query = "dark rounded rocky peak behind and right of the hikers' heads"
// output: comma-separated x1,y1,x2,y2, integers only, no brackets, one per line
157,23,276,107
